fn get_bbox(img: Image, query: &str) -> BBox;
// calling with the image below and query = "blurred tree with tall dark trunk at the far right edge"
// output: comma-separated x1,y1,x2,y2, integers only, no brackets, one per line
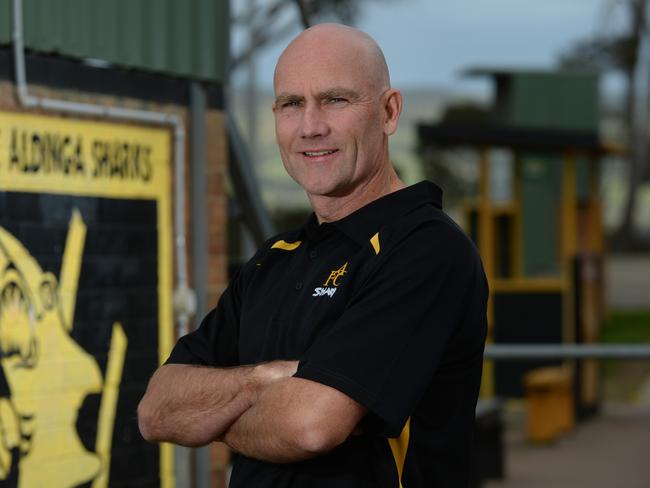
560,0,650,246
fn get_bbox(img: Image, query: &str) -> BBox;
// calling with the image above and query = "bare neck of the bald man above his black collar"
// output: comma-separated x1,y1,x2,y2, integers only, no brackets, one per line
309,167,406,223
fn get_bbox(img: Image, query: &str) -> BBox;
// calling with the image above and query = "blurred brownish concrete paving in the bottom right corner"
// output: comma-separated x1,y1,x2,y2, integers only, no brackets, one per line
483,405,650,488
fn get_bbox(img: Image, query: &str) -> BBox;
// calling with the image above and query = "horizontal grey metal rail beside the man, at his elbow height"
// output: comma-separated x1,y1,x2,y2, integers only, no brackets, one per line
484,344,650,361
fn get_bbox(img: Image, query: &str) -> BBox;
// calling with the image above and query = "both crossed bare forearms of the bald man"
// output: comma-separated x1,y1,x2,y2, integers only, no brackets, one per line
138,361,366,463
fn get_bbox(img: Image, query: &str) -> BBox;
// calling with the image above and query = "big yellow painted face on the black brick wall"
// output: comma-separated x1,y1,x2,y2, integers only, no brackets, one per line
0,221,102,487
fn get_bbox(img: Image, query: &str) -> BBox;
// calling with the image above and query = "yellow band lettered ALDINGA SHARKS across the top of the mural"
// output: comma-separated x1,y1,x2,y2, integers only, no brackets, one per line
0,112,171,198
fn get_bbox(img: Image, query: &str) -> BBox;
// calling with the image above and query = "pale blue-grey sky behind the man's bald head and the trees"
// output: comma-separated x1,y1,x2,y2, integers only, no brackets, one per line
233,0,624,95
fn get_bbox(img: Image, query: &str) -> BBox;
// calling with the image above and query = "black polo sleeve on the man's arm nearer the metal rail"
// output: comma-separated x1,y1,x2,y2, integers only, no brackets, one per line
296,219,487,437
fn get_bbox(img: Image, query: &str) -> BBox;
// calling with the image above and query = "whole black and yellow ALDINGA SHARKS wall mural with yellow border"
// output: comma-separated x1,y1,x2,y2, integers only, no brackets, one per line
0,112,173,488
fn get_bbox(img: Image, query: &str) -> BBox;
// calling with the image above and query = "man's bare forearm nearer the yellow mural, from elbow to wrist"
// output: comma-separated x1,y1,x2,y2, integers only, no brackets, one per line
138,361,298,447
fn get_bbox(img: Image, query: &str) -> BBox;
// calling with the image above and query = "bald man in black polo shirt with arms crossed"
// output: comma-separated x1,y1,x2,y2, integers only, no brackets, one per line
138,24,487,488
